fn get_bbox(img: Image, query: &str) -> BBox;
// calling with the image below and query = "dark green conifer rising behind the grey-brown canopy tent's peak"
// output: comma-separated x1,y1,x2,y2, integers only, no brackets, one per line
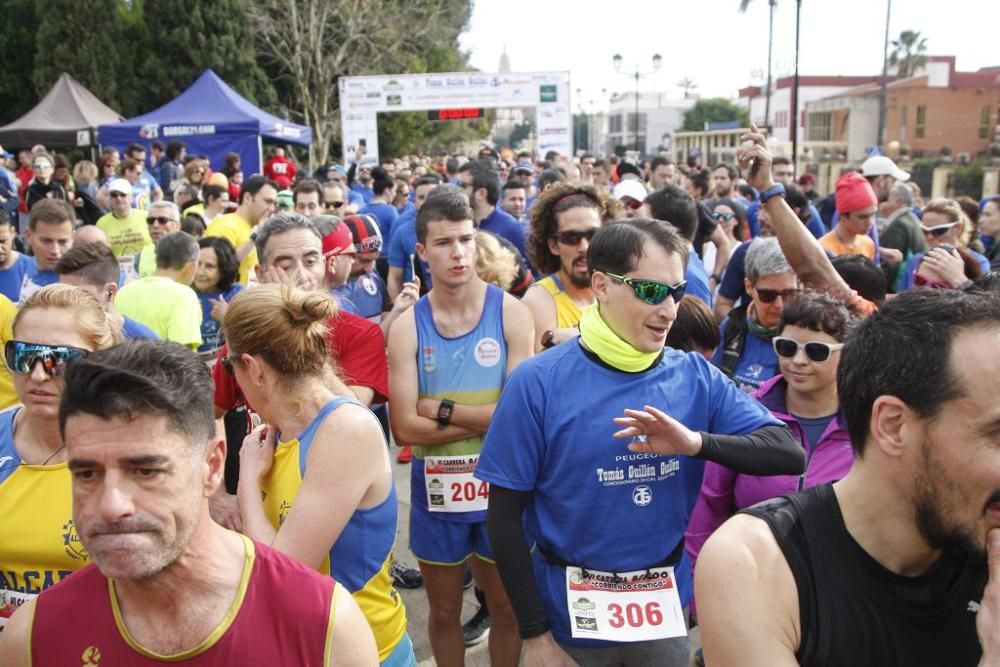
33,0,125,112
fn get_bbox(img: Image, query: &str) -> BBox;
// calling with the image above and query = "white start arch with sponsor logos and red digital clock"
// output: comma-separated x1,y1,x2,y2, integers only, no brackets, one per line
339,72,573,164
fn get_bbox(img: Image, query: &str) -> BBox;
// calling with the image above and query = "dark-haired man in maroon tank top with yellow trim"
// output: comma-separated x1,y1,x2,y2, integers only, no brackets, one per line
0,340,378,667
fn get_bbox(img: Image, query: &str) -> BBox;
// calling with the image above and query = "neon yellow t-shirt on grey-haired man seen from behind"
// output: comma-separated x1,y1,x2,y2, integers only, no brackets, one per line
115,276,201,349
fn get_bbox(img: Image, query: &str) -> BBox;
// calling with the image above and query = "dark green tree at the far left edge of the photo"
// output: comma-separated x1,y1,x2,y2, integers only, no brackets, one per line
0,0,38,125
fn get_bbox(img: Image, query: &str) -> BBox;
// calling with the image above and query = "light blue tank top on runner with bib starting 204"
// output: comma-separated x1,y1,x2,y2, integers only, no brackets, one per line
410,285,507,523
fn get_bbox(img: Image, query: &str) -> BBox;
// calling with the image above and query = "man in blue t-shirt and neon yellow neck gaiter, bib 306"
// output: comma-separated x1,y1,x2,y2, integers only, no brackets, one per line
476,220,804,667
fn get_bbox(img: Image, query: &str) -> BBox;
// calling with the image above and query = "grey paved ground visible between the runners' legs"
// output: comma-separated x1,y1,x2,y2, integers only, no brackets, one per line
393,460,698,667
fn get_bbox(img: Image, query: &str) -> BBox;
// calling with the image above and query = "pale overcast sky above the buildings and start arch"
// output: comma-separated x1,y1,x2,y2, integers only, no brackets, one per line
461,0,1000,111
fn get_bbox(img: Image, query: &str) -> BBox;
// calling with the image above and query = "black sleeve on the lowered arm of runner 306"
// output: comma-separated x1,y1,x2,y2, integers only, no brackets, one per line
486,488,552,639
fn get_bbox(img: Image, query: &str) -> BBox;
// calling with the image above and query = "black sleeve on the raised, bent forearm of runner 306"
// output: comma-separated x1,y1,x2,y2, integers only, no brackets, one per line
696,426,806,478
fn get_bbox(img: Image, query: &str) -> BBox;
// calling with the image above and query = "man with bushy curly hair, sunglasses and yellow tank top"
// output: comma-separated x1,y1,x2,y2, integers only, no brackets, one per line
522,183,615,352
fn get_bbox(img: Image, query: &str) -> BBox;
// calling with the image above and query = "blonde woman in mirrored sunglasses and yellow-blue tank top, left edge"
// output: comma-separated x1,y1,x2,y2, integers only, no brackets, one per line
0,285,122,616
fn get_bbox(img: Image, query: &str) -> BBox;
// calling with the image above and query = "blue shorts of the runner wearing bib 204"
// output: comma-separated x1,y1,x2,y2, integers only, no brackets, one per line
410,505,493,565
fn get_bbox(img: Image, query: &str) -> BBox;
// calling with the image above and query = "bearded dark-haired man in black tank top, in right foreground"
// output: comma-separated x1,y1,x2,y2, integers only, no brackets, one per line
695,290,1000,667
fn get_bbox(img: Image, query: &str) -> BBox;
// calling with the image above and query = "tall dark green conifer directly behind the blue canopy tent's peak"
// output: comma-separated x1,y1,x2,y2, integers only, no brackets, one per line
136,0,277,109
